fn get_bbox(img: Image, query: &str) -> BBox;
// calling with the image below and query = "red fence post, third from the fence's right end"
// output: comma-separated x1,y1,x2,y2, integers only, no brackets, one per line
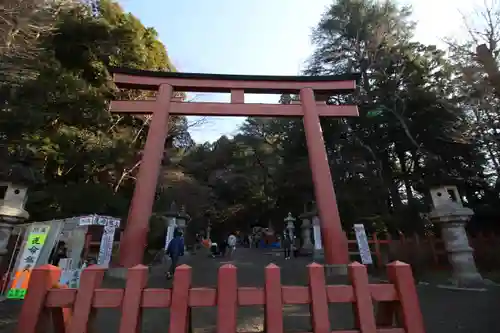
306,263,330,333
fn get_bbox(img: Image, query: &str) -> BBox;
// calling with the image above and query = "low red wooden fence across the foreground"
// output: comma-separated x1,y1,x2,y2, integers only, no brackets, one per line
17,262,424,333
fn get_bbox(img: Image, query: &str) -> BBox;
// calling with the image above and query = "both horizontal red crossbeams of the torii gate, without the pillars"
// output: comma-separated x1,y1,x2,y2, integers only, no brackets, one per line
111,68,358,117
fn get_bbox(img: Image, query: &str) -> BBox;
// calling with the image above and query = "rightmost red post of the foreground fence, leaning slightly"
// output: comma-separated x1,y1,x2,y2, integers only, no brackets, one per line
387,261,425,333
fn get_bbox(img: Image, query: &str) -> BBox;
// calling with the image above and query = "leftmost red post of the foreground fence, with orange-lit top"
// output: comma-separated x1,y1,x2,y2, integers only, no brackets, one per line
17,265,61,333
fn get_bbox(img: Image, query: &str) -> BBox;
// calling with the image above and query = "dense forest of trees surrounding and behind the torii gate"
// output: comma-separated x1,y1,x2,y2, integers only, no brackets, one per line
0,0,500,246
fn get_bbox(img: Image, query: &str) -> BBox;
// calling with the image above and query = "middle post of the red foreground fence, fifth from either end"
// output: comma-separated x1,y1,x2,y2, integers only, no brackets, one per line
217,264,238,333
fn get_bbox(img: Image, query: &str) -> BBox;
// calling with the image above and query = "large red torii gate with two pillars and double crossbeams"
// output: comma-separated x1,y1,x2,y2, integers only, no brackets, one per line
111,68,358,267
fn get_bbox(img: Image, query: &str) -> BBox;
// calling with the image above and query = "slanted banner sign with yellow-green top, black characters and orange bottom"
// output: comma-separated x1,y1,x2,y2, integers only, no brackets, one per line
7,224,50,299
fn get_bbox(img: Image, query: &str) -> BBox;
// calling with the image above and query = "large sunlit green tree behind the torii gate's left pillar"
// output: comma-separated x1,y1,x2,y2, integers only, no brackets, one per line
0,0,192,223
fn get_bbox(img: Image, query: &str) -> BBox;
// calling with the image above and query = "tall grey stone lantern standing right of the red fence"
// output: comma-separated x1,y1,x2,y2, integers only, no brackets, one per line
429,186,483,287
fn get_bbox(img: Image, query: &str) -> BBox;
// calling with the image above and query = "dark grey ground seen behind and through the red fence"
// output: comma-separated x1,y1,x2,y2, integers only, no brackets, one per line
0,249,500,333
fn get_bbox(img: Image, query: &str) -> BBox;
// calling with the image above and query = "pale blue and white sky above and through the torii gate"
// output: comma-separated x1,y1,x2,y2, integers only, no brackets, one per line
120,0,483,143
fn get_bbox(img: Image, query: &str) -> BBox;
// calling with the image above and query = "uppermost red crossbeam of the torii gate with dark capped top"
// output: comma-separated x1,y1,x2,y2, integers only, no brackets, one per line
111,68,359,95
